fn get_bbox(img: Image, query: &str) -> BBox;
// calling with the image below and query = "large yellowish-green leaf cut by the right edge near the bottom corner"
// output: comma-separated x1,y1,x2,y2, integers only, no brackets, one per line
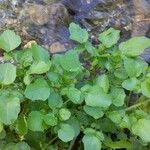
132,119,150,142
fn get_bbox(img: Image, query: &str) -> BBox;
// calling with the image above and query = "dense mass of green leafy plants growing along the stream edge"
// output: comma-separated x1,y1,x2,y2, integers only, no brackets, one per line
0,23,150,150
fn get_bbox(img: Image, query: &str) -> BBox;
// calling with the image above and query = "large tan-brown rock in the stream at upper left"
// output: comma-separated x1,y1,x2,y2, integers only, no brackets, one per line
25,3,69,26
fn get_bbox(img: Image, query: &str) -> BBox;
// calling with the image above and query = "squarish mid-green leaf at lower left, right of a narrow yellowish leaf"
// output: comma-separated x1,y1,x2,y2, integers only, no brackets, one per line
27,111,45,131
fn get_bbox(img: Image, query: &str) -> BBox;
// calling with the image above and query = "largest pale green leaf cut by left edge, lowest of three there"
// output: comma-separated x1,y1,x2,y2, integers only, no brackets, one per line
0,92,20,125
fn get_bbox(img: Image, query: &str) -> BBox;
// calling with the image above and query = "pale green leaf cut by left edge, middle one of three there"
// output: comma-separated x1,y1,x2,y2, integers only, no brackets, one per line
0,63,16,85
